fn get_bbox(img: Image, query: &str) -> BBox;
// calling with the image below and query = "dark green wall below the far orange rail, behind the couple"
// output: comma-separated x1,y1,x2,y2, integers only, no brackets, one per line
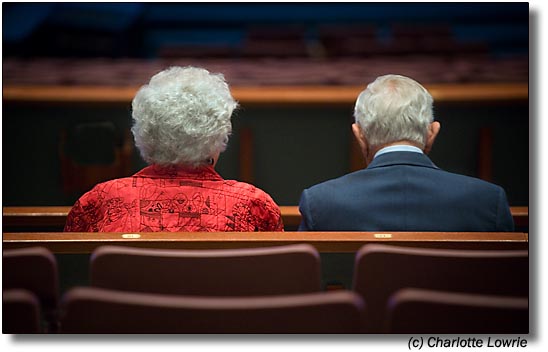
2,101,529,206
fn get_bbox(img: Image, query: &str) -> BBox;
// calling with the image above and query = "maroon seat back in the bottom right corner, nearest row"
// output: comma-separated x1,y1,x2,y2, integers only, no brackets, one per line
385,288,529,334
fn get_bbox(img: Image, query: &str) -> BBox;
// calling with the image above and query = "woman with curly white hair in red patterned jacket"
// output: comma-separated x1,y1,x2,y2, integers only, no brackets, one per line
65,67,283,232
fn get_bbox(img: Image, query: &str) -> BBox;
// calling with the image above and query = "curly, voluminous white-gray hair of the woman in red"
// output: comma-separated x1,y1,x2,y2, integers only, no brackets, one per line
131,66,238,167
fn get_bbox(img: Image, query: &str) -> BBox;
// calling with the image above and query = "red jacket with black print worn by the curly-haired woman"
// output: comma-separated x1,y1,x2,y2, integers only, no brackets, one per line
65,165,283,232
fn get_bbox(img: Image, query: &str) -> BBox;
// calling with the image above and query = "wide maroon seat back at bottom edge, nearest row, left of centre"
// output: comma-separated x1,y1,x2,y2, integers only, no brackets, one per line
61,287,365,334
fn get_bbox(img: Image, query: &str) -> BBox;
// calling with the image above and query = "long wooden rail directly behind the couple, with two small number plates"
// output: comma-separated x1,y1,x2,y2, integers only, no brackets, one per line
2,232,529,254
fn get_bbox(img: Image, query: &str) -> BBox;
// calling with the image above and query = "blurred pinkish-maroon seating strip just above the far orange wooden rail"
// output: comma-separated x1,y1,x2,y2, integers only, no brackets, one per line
2,56,529,87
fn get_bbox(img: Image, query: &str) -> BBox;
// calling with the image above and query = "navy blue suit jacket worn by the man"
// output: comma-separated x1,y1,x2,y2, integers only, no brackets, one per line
299,152,514,232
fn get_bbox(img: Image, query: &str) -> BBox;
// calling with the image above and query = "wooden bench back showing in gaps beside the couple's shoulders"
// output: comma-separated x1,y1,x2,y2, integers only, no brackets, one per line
2,206,529,232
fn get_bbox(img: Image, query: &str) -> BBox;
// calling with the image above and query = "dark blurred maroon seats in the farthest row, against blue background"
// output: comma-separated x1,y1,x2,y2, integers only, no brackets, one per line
158,23,489,58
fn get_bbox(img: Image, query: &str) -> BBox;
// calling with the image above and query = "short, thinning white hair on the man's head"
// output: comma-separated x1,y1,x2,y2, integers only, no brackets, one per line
354,75,434,148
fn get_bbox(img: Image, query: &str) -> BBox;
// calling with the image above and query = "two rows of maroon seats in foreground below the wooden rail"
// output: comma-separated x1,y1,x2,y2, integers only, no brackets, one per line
3,244,529,333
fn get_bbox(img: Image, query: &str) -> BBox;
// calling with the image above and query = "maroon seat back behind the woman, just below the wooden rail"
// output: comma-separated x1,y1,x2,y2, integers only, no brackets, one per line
90,244,321,296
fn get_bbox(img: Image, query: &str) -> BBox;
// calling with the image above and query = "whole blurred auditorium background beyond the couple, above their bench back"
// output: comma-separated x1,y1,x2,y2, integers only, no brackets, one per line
2,2,530,206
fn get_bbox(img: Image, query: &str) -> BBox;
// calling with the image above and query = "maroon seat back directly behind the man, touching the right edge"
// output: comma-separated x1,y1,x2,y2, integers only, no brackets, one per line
353,244,529,332
